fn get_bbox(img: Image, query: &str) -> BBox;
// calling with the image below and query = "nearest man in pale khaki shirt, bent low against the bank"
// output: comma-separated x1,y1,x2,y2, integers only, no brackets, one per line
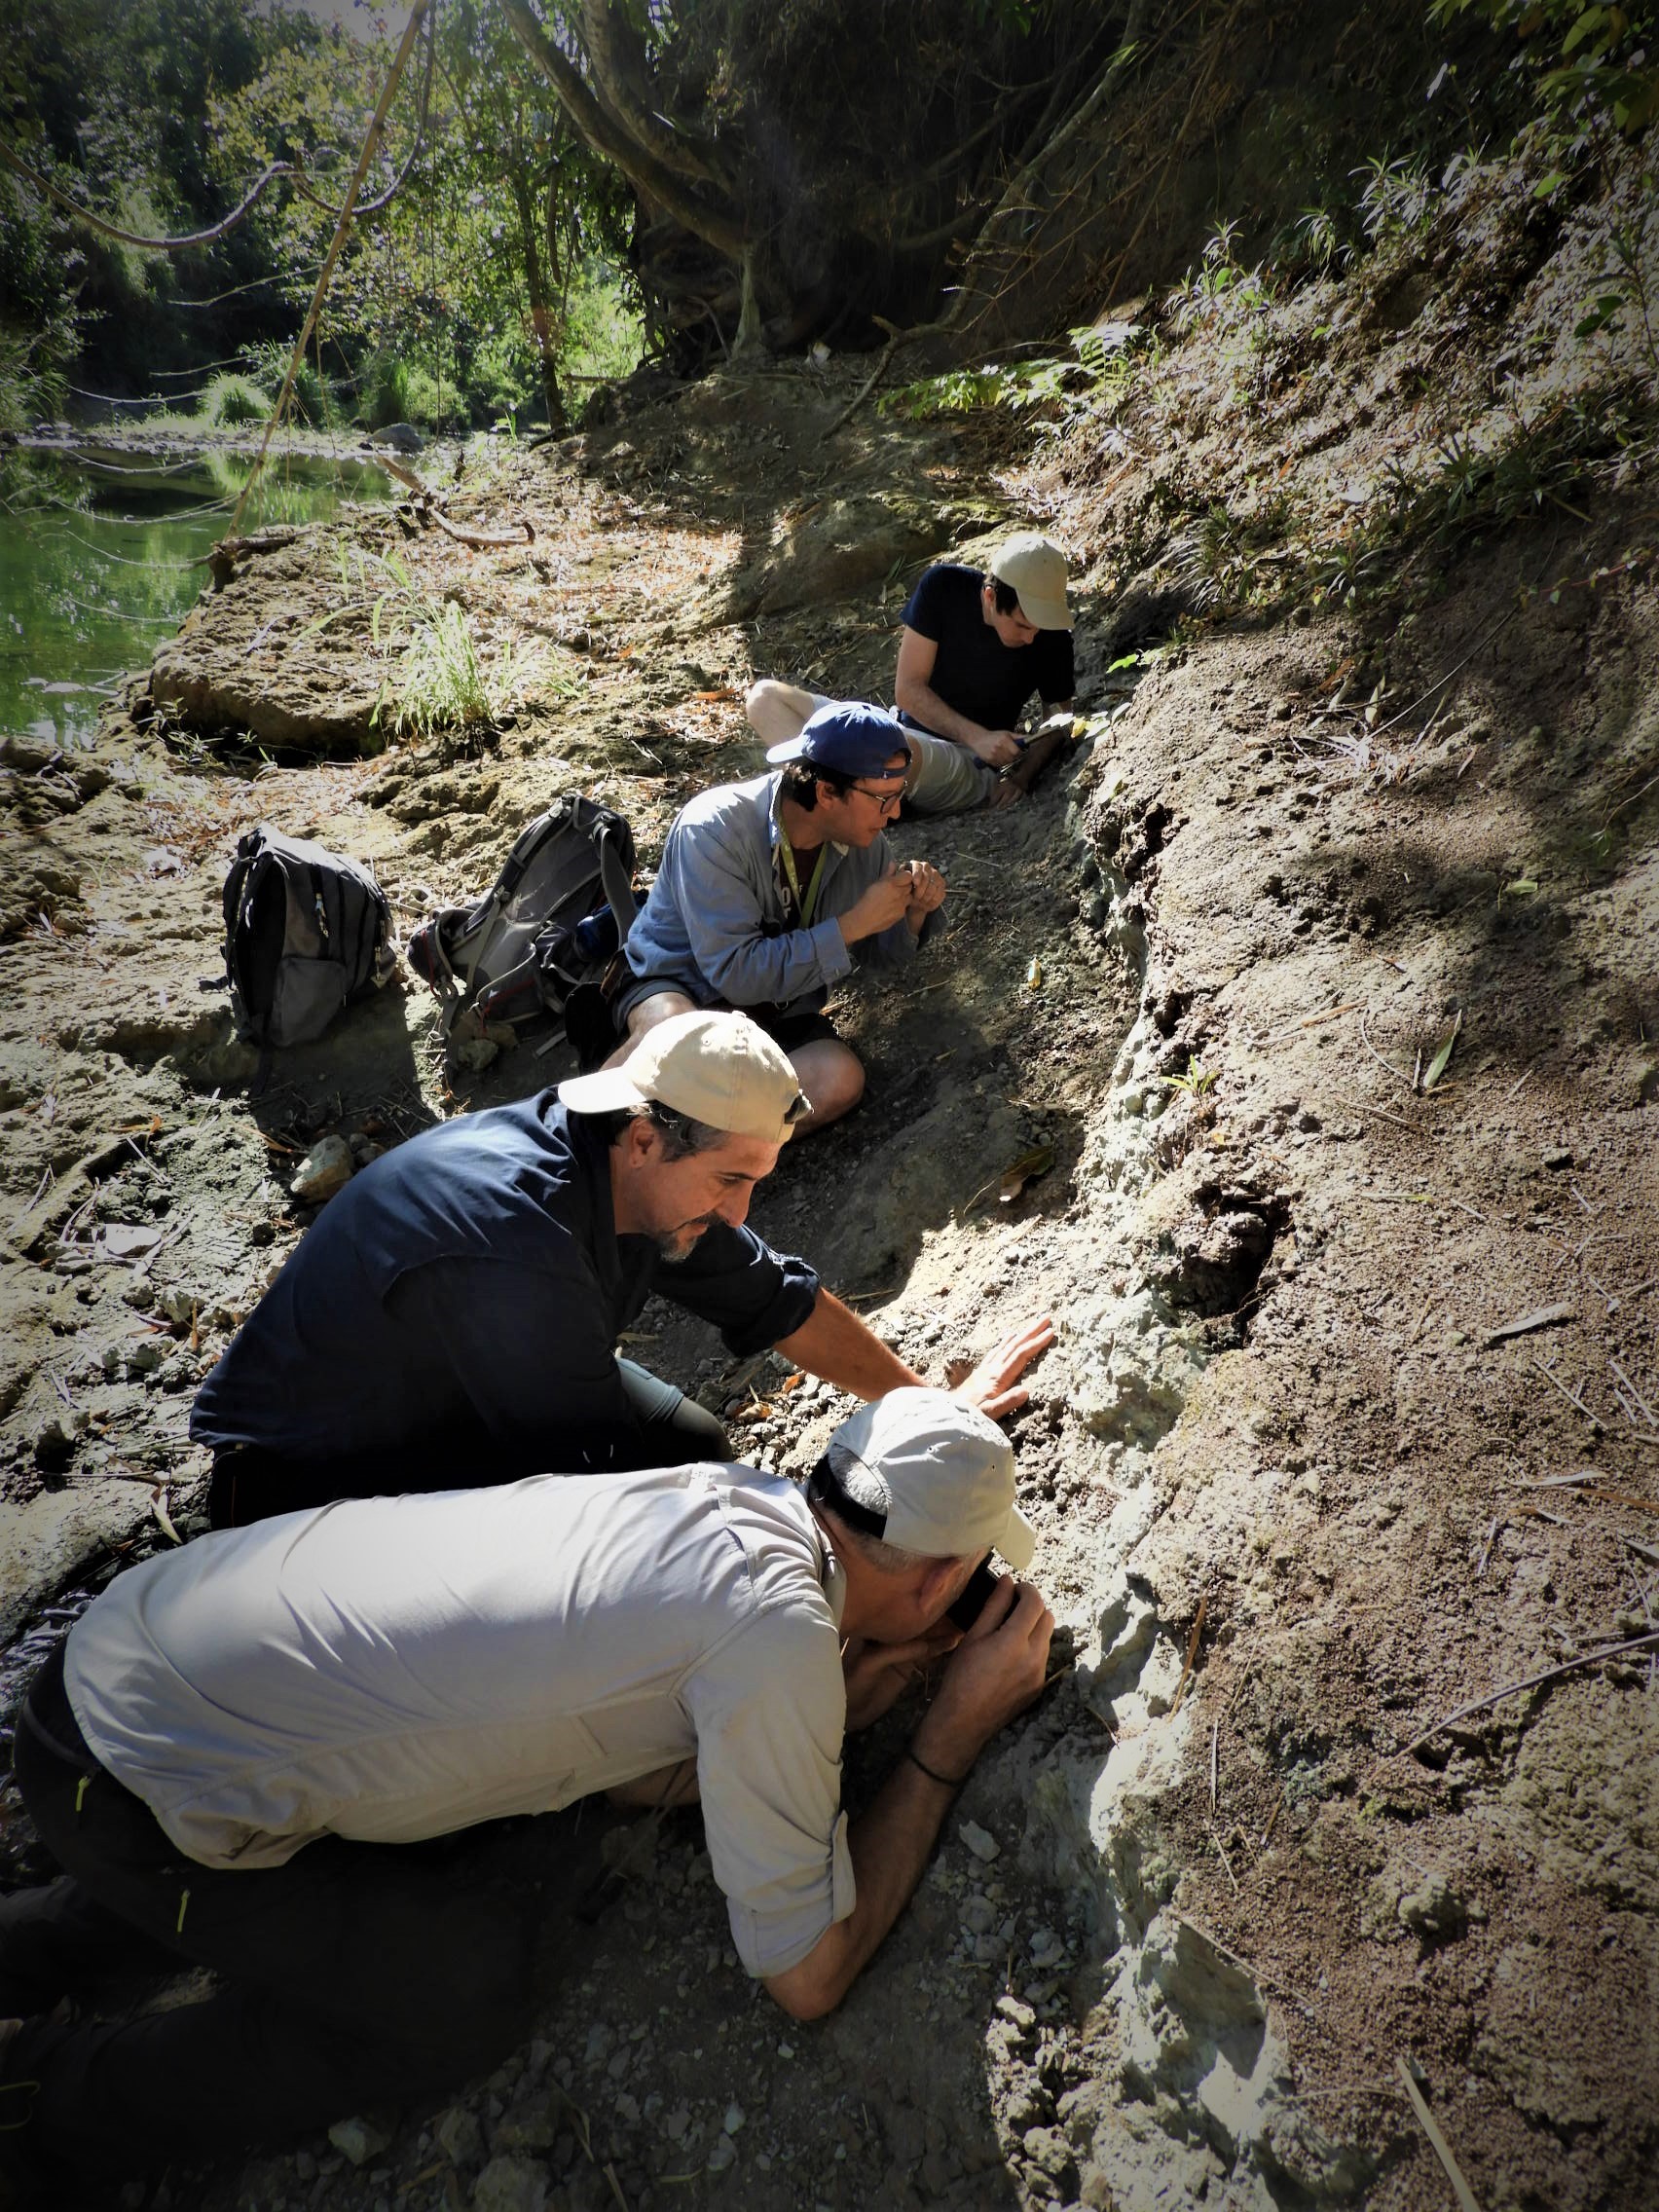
0,1387,1052,2203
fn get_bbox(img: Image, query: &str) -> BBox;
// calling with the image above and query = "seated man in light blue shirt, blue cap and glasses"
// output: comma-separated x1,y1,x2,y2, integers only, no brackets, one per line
608,701,944,1135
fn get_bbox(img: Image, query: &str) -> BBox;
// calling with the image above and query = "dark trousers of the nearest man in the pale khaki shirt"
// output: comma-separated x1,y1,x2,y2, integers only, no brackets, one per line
0,1648,534,2201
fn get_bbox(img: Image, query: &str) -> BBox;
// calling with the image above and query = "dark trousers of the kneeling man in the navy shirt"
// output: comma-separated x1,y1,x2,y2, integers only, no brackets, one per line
208,1360,732,1529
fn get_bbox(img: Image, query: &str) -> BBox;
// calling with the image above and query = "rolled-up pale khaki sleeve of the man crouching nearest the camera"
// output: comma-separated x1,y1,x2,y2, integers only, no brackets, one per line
683,1605,856,1979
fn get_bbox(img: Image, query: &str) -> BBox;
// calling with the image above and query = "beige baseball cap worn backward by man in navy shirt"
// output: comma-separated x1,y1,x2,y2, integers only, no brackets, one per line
560,1014,812,1144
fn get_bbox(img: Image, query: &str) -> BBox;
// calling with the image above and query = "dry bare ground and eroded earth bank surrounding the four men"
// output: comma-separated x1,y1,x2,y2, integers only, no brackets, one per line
0,147,1659,2212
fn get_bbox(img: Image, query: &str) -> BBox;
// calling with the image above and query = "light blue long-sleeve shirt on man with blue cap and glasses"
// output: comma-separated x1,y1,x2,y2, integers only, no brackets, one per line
626,774,934,1014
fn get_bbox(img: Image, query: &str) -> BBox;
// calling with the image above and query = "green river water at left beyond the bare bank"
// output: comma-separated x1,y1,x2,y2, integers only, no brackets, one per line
0,449,387,746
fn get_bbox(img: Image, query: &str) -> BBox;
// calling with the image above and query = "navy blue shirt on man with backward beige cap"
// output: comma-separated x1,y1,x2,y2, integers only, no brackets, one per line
190,1090,819,1489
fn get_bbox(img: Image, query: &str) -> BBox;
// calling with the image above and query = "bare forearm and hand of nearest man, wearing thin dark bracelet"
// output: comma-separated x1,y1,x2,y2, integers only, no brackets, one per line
765,1584,1055,2019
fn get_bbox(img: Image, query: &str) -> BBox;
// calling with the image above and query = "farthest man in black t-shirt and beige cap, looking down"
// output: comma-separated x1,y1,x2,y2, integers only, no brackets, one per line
748,531,1075,814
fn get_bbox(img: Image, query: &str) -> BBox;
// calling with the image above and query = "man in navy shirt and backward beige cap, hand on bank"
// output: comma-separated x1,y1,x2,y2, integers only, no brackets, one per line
190,1014,1052,1529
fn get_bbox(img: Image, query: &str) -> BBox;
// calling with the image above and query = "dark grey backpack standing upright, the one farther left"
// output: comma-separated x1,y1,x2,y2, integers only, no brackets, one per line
223,825,393,1051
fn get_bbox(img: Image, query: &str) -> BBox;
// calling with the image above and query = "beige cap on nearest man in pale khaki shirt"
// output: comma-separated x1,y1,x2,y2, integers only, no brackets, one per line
814,1384,1038,1572
